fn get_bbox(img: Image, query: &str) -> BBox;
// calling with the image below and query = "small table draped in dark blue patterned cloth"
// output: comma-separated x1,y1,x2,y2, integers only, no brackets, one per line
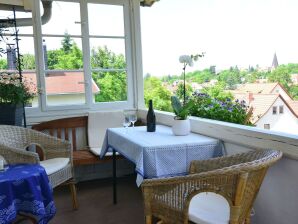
0,164,56,224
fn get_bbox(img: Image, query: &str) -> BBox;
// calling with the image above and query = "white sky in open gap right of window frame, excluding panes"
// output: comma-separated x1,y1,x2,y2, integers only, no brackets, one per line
141,0,298,76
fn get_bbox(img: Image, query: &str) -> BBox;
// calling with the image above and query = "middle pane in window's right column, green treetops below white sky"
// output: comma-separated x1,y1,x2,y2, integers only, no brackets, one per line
90,38,126,69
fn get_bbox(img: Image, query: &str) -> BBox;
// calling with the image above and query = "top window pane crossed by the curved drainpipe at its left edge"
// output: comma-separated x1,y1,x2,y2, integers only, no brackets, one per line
42,1,81,35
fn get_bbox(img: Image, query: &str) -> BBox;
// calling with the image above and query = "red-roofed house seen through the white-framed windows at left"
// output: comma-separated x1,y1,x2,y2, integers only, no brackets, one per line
23,71,100,107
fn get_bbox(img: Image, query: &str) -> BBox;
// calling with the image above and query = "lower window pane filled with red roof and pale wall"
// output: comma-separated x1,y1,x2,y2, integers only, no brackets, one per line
45,72,88,106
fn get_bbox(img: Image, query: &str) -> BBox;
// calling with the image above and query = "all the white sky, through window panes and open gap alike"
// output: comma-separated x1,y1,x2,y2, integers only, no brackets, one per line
0,0,298,76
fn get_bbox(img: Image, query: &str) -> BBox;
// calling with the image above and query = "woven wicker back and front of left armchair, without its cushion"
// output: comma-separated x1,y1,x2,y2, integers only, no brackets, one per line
0,125,73,187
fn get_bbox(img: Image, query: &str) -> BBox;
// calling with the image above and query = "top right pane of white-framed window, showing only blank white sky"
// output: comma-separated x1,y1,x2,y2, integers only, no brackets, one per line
88,4,124,36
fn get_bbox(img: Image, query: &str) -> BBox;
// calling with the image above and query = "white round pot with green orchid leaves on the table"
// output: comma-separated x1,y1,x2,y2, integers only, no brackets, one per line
171,96,192,135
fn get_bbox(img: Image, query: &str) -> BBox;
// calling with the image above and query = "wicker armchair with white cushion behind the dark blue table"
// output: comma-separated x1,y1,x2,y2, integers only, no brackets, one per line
0,125,78,209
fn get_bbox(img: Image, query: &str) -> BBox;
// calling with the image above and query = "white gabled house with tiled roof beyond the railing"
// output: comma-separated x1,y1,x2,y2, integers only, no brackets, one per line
231,83,298,135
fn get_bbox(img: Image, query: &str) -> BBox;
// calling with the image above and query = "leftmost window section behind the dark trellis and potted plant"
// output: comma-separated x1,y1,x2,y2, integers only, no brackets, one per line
0,10,39,108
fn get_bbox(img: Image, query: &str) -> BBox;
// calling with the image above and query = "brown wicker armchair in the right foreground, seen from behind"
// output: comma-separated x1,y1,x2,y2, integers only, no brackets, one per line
142,150,282,224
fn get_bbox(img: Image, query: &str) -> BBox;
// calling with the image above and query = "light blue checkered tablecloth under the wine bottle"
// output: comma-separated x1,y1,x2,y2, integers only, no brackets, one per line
101,125,224,185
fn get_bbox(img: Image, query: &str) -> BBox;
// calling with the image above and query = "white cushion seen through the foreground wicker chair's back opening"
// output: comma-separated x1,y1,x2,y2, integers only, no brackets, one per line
188,192,230,224
